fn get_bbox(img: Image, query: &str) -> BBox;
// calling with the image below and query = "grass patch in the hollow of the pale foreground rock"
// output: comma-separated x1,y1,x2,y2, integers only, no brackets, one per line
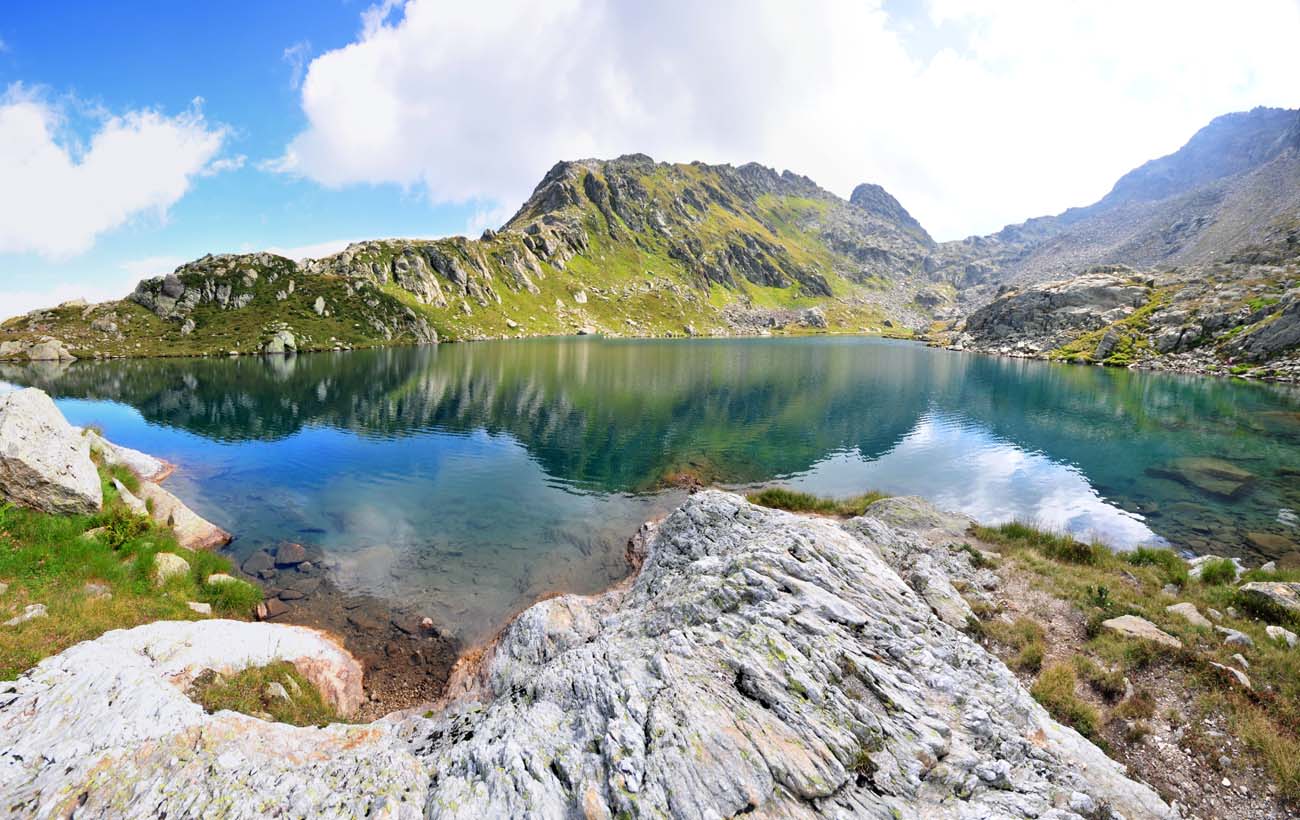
189,660,342,726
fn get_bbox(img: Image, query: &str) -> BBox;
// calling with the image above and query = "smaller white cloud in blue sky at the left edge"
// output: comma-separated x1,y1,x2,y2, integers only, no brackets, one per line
0,84,225,259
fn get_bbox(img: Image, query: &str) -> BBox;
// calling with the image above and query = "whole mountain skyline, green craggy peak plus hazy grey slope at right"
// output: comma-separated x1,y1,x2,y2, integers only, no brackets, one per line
0,108,1300,369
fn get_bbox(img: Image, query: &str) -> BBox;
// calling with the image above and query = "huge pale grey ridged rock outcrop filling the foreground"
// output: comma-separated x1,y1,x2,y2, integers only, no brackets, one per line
0,491,1175,820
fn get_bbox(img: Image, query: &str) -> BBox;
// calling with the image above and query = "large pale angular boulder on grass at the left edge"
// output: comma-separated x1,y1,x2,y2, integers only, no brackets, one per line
0,387,104,515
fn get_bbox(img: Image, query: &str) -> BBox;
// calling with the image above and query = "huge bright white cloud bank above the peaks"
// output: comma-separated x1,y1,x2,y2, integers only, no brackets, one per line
272,0,1300,238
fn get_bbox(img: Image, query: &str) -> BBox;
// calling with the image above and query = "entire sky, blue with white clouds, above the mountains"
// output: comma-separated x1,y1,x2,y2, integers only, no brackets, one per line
0,0,1300,318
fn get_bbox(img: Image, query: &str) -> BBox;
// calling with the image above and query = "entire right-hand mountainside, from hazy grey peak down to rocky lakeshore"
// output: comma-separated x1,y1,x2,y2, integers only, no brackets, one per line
941,108,1300,381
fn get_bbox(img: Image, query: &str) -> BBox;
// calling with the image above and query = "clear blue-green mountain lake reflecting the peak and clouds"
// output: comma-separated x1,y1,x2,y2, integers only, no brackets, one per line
0,338,1300,637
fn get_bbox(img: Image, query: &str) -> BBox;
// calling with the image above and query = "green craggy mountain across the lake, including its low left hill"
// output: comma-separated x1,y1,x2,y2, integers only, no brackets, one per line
0,155,953,357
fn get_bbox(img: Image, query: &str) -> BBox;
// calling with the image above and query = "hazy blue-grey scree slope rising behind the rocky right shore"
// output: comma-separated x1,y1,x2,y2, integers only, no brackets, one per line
940,108,1300,301
